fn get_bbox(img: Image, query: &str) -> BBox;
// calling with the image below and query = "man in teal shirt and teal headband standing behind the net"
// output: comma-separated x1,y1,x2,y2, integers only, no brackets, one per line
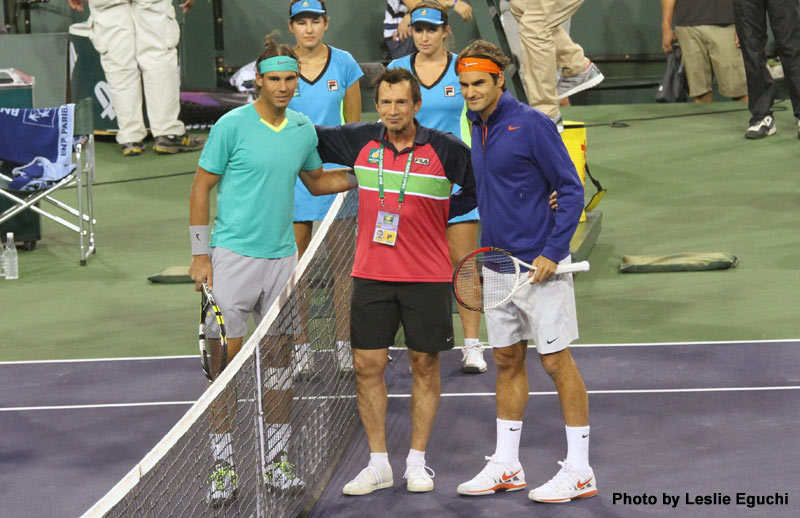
189,41,355,506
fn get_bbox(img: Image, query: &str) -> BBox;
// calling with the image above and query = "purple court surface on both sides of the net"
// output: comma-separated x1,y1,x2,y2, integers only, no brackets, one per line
0,341,800,518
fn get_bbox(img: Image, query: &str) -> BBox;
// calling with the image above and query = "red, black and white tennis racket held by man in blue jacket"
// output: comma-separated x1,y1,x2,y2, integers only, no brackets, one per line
453,247,589,311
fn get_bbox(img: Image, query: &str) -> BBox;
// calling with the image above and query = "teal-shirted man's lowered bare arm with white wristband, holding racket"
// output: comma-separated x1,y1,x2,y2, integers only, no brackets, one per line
189,170,219,291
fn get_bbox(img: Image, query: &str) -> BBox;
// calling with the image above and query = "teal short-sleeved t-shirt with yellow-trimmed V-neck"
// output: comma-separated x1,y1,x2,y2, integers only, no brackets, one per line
199,104,322,258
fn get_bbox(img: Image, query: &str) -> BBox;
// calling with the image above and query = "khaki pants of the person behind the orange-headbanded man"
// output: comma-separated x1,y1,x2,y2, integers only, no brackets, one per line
510,0,589,118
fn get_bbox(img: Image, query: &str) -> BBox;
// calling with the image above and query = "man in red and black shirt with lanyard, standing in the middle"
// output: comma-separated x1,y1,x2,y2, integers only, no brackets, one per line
317,68,476,495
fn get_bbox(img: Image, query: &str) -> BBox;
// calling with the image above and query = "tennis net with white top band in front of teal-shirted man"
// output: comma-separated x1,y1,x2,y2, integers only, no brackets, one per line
84,191,358,518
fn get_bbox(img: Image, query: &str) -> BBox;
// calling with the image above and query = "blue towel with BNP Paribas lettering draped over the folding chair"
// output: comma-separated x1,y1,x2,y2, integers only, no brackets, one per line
0,104,75,187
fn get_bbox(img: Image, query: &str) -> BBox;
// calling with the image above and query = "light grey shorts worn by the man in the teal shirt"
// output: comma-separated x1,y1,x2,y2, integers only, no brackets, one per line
211,247,297,338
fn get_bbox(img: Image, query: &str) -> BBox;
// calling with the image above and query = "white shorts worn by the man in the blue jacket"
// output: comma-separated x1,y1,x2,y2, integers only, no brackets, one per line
484,256,578,354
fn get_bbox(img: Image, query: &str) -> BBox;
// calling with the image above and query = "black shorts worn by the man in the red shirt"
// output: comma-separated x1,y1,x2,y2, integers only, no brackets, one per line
350,277,453,353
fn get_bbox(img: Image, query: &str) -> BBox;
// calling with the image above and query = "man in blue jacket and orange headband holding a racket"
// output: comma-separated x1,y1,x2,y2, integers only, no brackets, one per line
457,40,597,508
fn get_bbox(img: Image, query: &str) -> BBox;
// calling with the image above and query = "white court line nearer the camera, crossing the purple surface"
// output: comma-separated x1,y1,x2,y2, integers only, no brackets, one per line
0,385,800,412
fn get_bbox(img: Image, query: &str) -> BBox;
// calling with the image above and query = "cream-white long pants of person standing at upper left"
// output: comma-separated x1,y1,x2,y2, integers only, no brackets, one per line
89,0,186,144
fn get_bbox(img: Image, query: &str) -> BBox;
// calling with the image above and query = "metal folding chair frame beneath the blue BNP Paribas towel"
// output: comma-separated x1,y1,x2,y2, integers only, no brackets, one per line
0,98,96,266
